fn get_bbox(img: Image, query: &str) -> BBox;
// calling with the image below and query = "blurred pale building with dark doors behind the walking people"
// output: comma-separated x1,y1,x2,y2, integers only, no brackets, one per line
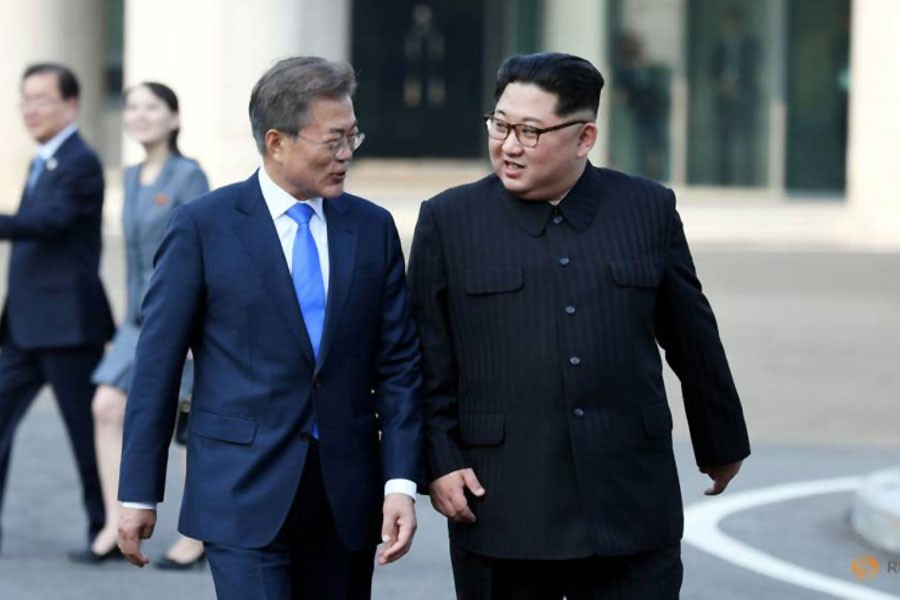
0,0,900,247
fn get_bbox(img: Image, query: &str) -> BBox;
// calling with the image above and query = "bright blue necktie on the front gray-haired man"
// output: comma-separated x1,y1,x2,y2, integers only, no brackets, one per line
287,202,325,438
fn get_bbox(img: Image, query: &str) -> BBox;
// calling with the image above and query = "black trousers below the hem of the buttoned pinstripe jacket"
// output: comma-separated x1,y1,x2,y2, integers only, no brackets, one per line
450,542,683,600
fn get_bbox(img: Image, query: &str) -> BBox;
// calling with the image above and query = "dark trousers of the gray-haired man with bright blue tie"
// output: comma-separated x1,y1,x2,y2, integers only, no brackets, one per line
206,441,375,600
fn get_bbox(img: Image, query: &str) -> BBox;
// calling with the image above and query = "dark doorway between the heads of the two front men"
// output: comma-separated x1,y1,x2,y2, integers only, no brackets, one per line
352,0,485,158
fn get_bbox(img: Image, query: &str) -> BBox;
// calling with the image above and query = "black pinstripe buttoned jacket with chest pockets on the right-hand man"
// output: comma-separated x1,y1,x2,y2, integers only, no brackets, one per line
409,165,749,559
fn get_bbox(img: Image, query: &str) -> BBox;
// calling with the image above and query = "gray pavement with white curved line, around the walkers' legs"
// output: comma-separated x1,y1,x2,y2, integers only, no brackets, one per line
0,200,900,600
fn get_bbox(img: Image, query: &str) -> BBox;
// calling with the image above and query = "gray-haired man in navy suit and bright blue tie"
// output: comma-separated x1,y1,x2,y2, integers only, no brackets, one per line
119,58,423,599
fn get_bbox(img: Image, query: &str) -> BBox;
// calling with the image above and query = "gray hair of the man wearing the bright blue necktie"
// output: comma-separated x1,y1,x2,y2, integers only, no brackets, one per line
250,56,356,156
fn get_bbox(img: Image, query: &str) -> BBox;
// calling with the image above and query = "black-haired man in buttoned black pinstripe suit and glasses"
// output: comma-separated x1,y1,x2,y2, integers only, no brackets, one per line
409,54,749,600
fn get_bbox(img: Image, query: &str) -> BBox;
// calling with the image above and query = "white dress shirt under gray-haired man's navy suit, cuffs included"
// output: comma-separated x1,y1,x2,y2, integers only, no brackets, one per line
122,167,416,509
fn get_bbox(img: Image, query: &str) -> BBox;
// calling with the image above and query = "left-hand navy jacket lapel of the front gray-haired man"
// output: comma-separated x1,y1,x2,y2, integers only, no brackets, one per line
233,174,318,365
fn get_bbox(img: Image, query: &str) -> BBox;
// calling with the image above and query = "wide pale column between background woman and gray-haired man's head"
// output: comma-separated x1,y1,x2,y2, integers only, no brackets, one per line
123,0,350,187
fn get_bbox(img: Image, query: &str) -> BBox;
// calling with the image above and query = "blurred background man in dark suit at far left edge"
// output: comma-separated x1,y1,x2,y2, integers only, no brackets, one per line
0,64,113,556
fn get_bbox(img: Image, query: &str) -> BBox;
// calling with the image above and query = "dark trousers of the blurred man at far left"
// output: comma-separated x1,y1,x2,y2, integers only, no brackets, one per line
0,339,106,543
